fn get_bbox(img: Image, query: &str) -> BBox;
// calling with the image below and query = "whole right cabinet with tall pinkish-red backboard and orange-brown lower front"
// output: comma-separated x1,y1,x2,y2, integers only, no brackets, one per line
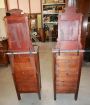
53,0,83,100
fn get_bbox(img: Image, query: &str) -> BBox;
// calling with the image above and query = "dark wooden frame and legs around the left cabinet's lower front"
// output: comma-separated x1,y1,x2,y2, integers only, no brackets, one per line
7,48,41,100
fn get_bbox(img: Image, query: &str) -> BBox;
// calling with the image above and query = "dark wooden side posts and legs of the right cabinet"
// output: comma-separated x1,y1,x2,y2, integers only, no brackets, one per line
52,49,83,100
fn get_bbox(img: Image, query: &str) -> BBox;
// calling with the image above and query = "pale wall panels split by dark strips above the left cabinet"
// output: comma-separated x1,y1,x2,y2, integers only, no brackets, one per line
7,0,41,13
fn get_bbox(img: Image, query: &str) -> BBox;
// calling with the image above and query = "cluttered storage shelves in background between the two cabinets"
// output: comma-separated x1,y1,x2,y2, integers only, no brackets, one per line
42,0,66,41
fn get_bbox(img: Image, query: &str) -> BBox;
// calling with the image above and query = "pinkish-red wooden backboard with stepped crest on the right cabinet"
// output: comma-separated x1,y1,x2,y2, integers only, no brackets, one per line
57,7,82,50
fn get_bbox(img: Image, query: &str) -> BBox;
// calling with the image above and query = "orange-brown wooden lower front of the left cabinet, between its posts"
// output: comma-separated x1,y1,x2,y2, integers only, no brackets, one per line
12,55,38,92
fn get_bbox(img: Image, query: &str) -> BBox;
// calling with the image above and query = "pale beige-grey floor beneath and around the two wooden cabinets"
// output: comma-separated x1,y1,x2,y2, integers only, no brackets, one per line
0,42,90,105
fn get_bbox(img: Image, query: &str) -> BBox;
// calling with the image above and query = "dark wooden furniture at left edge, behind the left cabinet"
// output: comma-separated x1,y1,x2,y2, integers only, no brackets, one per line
0,39,9,66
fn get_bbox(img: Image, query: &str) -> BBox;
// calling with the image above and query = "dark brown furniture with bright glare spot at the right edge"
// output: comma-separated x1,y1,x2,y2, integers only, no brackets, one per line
77,0,90,48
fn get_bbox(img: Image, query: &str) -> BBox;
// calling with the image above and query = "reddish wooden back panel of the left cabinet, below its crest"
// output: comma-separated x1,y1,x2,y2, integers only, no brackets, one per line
6,15,33,51
